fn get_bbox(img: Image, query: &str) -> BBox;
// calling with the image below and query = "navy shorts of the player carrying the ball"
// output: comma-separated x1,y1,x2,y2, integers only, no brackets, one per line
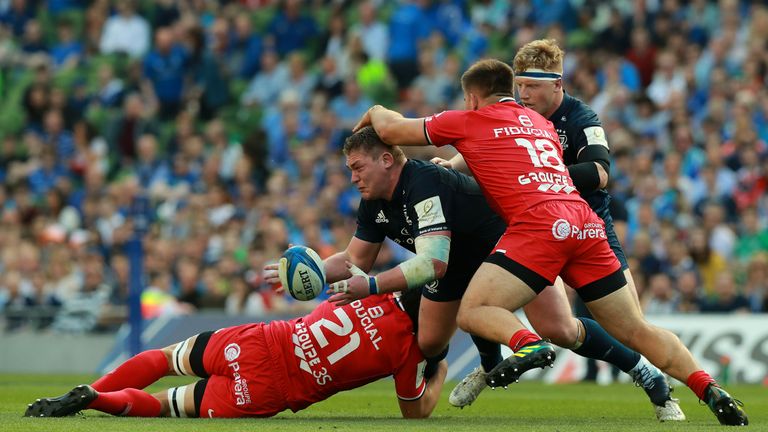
421,242,492,302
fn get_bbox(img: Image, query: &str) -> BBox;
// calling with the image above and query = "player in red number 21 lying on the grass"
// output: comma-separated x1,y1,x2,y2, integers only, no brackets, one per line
24,292,447,418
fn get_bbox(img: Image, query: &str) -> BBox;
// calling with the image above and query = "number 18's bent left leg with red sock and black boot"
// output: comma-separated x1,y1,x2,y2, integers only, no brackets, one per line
458,253,555,386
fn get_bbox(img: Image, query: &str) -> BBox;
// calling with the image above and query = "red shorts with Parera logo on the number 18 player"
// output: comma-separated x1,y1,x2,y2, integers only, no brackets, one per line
486,201,626,302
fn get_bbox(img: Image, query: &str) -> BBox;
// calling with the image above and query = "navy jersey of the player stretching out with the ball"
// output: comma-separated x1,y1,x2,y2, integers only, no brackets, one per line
355,160,505,256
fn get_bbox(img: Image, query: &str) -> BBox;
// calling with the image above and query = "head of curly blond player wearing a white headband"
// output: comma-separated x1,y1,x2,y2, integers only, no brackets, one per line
512,39,564,117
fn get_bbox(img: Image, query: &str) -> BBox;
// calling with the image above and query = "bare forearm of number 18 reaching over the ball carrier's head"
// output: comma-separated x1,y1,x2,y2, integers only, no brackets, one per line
353,105,429,146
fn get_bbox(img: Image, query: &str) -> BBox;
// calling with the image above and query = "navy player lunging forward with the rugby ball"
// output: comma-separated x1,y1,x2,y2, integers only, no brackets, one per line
300,127,670,422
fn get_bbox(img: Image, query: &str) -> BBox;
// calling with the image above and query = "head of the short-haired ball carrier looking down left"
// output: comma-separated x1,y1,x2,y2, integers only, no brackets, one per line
344,126,406,200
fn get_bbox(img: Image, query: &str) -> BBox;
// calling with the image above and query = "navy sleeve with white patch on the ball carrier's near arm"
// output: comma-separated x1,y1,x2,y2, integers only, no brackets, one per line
407,165,453,237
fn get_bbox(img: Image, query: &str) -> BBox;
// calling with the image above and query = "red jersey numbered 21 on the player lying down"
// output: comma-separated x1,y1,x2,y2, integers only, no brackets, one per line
265,294,426,411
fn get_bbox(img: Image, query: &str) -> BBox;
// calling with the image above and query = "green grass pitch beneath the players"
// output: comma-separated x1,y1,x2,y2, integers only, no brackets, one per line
0,375,768,432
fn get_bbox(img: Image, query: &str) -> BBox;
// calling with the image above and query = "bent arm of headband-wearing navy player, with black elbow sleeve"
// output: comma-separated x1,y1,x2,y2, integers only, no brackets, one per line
568,126,611,195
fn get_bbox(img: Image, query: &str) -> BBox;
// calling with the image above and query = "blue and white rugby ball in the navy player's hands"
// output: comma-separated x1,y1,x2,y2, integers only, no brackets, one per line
277,246,325,301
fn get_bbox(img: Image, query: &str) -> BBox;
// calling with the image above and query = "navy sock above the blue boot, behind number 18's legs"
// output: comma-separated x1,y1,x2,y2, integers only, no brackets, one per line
573,318,640,373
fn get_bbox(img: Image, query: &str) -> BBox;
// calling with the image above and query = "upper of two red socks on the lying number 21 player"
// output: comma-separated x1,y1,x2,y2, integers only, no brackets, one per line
91,350,168,392
